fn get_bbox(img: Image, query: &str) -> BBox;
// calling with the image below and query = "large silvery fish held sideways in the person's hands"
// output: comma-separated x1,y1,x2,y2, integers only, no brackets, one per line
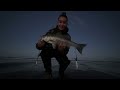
41,35,87,54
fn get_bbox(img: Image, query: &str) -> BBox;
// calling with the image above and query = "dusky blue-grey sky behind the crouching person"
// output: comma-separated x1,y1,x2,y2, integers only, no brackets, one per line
0,11,120,59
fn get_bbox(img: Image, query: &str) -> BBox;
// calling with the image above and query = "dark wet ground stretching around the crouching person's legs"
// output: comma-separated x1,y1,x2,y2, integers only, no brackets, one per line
0,60,120,79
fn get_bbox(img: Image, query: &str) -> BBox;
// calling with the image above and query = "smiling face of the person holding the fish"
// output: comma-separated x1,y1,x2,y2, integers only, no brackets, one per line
58,17,67,30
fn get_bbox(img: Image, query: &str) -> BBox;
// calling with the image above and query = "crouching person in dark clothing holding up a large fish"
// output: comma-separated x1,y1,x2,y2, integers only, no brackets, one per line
36,12,71,79
